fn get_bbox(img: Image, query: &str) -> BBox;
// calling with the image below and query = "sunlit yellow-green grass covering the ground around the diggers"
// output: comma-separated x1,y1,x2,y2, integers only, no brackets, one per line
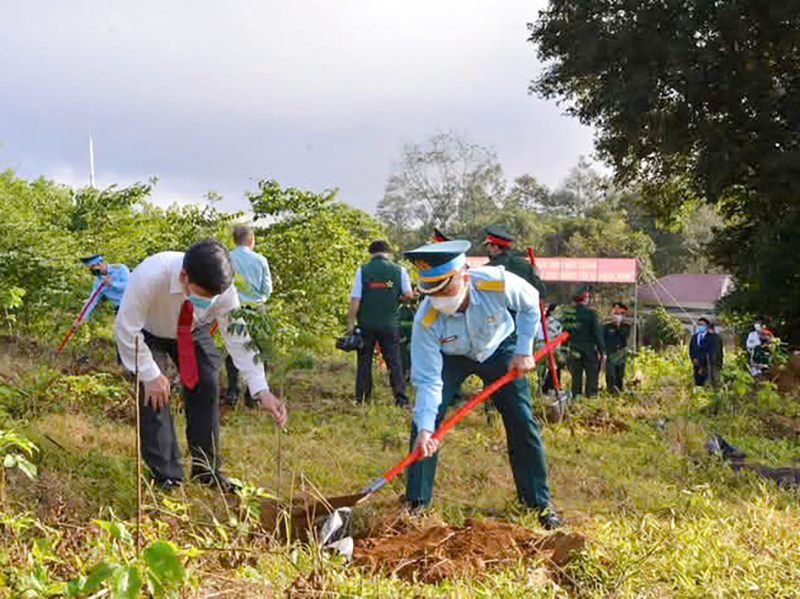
0,345,800,598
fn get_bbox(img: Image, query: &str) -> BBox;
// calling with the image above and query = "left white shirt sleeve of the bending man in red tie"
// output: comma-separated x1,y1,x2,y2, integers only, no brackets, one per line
114,261,161,383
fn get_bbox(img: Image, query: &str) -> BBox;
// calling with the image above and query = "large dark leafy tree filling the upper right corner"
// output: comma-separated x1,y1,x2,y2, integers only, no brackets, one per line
529,0,800,340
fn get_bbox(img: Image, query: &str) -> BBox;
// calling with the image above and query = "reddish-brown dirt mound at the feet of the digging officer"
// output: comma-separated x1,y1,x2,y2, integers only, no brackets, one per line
353,518,586,583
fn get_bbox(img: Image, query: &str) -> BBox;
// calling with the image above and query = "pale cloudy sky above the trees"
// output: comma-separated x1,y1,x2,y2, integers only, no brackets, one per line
0,0,592,212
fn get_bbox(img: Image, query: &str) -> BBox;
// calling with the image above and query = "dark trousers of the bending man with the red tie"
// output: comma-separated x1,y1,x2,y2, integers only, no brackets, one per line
140,327,221,480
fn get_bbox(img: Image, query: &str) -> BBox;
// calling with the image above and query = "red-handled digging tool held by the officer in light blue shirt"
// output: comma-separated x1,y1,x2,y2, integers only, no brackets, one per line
261,332,569,538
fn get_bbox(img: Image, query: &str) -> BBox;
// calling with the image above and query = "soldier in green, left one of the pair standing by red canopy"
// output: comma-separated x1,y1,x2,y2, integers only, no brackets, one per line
562,285,605,397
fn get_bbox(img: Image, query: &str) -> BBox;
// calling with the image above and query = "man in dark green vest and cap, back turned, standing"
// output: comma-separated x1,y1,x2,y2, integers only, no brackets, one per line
347,241,413,406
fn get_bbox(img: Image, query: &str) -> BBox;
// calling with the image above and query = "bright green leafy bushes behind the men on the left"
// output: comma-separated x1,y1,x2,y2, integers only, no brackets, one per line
0,170,383,346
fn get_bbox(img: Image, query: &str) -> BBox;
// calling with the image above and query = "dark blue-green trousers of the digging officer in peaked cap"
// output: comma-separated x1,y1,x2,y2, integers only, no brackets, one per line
406,341,550,509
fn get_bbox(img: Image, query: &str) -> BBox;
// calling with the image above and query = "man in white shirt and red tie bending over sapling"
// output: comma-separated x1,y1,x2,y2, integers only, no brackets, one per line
114,239,287,491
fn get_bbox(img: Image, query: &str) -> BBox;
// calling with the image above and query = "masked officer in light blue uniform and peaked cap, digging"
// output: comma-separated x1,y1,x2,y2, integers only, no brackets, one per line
406,240,561,529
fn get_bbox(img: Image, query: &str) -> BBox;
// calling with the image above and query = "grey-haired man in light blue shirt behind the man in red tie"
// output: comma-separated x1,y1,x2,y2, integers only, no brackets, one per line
225,225,272,406
